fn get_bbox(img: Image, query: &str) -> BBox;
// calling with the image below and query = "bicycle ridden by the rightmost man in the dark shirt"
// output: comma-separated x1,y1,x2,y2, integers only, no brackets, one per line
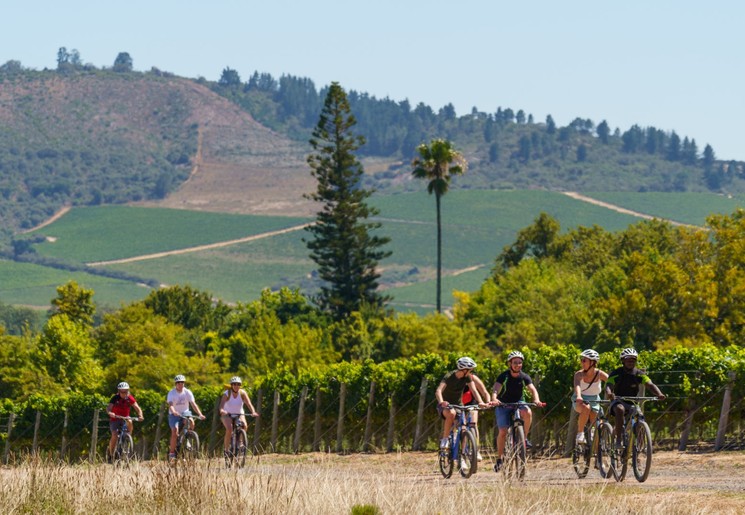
611,397,658,483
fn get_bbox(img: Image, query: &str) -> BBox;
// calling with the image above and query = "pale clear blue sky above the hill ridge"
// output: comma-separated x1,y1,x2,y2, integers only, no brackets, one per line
5,0,745,160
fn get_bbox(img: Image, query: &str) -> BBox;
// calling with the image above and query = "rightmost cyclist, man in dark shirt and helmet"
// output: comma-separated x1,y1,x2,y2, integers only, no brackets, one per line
605,347,665,444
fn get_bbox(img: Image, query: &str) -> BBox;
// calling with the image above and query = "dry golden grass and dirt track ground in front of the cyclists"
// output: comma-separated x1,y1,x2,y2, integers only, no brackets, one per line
0,452,745,514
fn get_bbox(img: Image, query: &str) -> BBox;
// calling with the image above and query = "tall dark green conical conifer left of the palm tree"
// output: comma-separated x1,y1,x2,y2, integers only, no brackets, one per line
306,83,390,319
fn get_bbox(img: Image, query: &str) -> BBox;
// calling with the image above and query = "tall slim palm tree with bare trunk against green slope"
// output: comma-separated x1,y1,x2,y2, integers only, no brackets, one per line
411,138,468,313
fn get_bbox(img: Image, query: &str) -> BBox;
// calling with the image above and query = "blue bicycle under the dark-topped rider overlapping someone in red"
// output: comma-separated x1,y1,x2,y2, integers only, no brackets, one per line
438,404,481,479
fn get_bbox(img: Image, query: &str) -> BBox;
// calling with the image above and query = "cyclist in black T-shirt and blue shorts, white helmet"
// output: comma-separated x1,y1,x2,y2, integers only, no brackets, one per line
491,351,545,472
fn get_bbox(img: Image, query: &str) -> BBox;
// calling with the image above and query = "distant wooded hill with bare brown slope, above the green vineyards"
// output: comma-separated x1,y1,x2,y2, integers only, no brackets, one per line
0,62,745,242
